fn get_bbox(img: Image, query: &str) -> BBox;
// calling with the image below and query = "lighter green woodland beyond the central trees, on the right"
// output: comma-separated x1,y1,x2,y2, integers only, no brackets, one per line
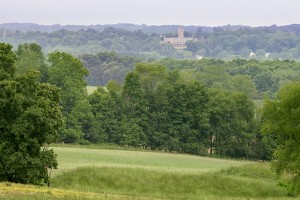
157,59,300,98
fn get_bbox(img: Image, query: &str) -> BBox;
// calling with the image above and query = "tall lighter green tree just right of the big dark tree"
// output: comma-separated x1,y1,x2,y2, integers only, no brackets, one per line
47,52,92,143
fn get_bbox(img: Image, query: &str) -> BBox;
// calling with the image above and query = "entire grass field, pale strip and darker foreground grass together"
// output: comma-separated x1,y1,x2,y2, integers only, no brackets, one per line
0,145,299,200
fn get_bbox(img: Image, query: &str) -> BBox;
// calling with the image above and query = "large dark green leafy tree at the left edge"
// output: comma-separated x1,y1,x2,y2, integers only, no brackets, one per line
0,43,63,184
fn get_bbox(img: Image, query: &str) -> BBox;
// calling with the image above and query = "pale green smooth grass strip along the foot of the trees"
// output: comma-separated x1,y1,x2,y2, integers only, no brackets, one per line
52,147,252,175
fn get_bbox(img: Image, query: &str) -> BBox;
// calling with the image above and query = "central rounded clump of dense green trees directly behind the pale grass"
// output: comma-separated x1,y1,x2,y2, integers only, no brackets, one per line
86,64,266,158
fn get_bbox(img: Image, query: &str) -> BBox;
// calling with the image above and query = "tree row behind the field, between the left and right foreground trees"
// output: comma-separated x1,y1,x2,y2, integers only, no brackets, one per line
5,44,273,159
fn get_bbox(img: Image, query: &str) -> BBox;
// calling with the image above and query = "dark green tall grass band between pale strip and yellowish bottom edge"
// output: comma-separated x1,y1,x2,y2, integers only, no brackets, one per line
52,167,287,199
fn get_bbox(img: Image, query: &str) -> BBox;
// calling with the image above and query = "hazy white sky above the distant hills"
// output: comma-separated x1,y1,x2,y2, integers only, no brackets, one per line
0,0,300,26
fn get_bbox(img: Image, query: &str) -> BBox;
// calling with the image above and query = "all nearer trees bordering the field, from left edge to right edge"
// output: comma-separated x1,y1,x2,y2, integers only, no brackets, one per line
0,43,300,191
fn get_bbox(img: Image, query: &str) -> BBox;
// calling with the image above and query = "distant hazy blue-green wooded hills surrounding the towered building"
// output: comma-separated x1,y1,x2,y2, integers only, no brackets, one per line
0,24,300,60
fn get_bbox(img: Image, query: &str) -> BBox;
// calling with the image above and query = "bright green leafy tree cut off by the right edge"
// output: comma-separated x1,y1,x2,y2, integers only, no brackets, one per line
263,82,300,192
